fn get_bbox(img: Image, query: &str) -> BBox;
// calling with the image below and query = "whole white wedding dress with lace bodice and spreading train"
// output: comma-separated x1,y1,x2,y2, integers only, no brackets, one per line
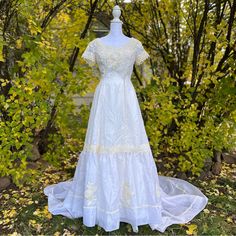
44,38,208,232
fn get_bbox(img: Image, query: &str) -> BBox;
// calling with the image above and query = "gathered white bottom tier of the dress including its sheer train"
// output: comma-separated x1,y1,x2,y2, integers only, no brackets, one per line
44,151,208,232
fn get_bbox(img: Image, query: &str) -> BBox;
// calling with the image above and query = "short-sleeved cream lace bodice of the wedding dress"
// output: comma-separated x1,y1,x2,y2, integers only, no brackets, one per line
81,37,149,79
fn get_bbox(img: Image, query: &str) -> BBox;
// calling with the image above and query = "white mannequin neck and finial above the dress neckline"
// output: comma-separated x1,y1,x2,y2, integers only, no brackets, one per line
100,5,130,46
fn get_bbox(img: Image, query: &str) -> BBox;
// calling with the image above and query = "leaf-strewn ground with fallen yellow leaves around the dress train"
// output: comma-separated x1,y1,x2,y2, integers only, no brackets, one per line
0,155,236,236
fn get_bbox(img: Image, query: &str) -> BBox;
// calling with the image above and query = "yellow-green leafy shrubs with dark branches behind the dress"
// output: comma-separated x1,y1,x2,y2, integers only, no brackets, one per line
0,0,236,185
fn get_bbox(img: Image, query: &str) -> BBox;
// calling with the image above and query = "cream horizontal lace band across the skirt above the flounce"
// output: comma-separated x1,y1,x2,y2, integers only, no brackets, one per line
83,143,150,153
